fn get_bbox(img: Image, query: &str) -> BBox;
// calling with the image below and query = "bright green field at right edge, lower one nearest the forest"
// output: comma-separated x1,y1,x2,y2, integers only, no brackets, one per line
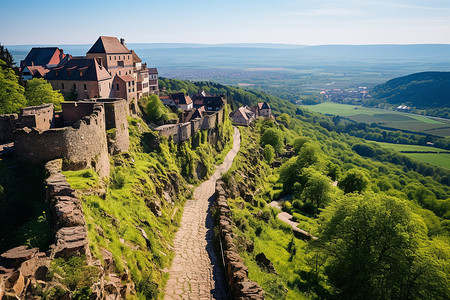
373,142,450,169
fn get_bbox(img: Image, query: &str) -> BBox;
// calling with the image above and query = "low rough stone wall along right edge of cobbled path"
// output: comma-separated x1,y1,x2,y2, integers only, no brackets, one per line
215,181,265,300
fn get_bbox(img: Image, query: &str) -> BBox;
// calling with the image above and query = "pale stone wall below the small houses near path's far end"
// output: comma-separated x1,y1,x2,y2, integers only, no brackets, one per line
156,108,224,143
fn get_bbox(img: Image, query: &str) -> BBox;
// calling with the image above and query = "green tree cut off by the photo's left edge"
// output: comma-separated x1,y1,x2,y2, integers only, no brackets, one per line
0,60,27,114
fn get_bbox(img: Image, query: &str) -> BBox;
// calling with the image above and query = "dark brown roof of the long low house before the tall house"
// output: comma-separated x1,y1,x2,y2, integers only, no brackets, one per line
45,58,111,81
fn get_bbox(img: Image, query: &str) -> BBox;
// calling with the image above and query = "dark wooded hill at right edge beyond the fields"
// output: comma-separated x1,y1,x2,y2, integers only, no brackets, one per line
371,72,450,109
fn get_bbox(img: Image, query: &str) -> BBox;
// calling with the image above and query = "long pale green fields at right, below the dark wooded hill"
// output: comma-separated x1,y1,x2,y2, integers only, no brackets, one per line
303,102,450,137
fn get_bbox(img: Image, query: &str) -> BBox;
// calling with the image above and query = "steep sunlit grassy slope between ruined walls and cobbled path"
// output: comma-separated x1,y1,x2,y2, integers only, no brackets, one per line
65,113,232,299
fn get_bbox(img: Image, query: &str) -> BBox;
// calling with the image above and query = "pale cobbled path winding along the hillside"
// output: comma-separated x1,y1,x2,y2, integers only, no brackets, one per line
165,128,241,300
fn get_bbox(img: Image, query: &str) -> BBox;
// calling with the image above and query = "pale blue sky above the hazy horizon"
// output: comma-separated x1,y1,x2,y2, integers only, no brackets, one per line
0,0,450,45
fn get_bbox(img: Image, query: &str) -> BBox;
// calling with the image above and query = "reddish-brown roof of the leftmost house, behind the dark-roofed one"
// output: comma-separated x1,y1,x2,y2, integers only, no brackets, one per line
20,47,66,69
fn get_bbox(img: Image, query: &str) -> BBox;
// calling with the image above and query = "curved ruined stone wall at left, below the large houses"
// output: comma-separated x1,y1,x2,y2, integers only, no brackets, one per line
14,103,109,176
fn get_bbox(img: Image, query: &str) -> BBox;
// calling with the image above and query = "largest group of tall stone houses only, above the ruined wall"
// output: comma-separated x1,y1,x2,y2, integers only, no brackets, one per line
20,36,158,107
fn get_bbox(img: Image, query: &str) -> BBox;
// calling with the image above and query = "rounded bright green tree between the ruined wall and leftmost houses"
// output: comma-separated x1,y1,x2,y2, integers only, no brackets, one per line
25,78,64,110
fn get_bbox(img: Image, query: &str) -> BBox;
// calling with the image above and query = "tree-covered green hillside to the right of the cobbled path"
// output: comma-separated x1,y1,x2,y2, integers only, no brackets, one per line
191,84,450,299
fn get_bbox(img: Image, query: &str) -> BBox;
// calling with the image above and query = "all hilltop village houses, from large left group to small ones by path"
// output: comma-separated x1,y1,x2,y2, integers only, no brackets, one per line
20,36,271,126
